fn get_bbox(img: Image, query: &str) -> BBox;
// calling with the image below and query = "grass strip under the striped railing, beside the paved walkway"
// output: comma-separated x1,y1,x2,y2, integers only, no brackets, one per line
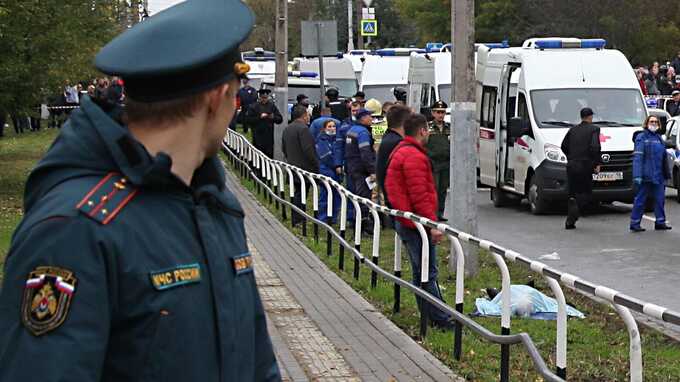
226,147,680,382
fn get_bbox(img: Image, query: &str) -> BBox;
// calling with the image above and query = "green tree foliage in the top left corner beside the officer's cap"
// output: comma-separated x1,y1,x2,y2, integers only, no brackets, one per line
0,0,120,113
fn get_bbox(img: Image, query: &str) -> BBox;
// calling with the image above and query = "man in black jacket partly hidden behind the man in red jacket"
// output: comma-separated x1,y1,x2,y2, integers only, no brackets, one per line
375,105,411,206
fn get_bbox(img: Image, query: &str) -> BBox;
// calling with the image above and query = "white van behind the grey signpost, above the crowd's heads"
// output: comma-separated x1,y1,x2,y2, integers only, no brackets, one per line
294,54,359,98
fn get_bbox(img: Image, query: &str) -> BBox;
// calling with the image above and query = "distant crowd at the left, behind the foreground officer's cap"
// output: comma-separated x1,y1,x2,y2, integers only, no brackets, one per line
0,77,125,138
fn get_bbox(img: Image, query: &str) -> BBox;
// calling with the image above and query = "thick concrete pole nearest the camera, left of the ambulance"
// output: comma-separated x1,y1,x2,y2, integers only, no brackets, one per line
447,0,479,276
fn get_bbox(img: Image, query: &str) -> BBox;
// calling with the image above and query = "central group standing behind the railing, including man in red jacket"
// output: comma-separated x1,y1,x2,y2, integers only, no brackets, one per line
232,82,451,328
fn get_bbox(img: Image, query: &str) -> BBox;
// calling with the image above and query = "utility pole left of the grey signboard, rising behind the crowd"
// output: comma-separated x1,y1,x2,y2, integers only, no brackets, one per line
274,0,288,160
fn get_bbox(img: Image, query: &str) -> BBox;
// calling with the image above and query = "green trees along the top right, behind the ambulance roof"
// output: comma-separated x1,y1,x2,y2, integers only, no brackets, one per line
396,0,680,65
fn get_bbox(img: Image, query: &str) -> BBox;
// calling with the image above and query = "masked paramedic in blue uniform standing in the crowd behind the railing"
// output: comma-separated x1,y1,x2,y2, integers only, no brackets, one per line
316,118,340,224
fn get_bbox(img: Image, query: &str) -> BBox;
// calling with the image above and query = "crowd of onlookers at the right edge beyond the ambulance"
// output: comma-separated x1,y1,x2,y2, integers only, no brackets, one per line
635,52,680,96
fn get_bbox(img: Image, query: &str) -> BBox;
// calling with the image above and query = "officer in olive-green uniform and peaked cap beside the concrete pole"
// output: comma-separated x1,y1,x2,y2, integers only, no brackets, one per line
426,101,451,221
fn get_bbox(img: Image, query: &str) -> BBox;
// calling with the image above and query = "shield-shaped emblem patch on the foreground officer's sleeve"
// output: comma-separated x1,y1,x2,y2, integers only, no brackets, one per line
21,267,77,336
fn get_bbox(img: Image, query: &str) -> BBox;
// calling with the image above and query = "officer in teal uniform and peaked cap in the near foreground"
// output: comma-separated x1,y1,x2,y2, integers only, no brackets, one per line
0,0,281,382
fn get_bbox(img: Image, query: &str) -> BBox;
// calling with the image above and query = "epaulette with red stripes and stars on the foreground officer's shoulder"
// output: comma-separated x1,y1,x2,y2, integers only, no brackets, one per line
76,172,138,225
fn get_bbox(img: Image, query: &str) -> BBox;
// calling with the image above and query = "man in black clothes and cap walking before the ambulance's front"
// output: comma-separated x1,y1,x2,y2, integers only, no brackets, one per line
562,107,600,229
